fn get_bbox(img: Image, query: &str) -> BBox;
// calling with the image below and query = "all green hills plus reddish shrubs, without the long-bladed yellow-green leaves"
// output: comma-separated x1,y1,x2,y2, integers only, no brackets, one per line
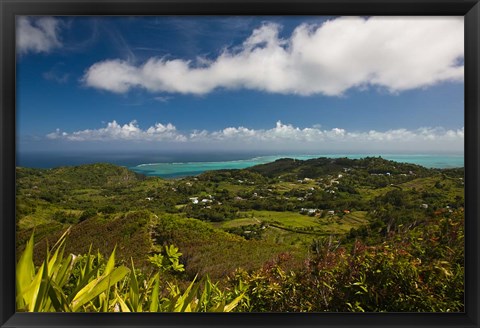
16,157,464,311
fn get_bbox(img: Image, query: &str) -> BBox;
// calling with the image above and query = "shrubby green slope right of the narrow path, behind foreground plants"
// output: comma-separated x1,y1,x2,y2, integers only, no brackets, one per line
153,215,301,279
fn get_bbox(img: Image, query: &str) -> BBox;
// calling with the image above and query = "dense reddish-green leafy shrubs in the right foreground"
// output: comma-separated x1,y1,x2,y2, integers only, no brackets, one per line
231,212,464,312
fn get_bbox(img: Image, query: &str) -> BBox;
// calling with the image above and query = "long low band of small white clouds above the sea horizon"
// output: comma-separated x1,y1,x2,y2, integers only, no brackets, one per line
47,121,464,151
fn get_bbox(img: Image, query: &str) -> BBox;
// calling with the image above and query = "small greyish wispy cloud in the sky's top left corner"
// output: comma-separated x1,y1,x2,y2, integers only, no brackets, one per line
16,16,62,54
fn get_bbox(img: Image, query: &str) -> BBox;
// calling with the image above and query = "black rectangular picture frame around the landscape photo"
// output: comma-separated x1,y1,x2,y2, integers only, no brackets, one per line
0,0,480,328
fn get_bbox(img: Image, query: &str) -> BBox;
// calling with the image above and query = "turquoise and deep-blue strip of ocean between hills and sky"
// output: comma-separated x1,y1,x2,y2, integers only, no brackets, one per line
16,152,464,176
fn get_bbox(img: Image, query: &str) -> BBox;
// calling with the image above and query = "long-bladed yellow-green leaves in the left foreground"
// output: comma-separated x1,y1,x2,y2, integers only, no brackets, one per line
16,230,244,312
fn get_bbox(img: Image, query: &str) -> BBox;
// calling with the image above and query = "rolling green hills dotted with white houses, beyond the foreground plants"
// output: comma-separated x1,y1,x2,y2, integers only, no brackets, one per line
16,157,464,279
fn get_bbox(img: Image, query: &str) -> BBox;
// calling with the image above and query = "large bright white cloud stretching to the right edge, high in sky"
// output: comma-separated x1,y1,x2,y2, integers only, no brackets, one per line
83,17,464,96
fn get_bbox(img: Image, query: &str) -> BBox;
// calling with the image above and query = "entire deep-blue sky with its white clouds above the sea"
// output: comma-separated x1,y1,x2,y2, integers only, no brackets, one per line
17,17,464,153
